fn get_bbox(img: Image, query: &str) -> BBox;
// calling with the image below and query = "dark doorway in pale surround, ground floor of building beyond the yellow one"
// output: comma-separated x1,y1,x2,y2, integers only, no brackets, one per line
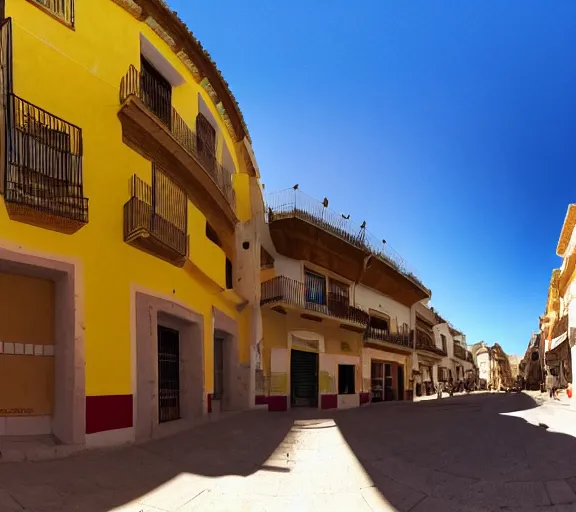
290,350,318,407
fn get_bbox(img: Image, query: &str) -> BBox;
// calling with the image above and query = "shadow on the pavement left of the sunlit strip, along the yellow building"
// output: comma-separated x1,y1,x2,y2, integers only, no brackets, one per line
0,410,318,512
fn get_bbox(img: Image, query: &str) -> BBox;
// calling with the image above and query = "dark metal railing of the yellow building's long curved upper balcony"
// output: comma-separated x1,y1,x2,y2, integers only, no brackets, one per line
120,65,236,208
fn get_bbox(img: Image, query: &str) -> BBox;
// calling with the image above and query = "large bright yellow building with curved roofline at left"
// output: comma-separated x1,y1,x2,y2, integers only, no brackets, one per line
0,0,263,445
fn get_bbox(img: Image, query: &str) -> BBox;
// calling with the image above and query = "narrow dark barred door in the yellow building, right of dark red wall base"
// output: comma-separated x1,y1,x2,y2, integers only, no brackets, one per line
158,325,180,423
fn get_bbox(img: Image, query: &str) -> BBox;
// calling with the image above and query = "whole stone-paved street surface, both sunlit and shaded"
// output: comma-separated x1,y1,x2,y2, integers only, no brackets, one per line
0,393,576,512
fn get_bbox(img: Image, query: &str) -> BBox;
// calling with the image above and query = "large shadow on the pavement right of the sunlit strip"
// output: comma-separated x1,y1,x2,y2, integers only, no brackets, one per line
337,393,576,512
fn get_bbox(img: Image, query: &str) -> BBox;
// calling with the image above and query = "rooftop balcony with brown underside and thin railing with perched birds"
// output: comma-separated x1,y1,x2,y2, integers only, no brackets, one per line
266,189,430,306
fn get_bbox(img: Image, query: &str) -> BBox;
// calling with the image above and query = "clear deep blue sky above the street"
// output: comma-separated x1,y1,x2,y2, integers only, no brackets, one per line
170,0,576,354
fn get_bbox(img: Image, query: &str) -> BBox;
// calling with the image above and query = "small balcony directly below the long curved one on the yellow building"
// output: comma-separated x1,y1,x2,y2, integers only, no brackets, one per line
124,173,189,267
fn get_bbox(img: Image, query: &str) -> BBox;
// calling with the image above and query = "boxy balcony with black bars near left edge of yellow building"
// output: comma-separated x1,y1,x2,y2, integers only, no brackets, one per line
3,94,88,234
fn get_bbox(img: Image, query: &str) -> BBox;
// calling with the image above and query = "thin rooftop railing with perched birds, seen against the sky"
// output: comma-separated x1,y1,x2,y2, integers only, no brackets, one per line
266,188,427,290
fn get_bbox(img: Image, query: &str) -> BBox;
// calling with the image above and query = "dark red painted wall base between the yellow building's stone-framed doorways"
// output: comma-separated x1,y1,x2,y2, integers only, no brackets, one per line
86,395,133,434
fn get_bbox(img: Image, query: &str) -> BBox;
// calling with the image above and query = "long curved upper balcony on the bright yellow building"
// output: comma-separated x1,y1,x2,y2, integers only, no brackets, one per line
118,66,237,249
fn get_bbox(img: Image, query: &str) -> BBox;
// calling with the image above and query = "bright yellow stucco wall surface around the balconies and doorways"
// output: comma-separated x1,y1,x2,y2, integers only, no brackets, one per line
0,0,250,395
